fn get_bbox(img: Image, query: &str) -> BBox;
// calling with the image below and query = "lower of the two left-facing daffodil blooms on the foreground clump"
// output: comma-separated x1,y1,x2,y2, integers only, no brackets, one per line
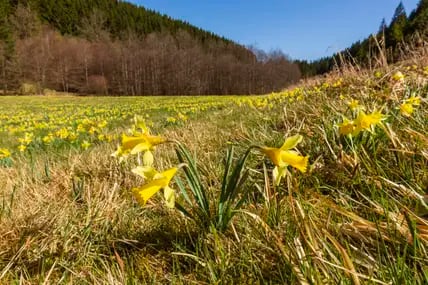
132,167,178,208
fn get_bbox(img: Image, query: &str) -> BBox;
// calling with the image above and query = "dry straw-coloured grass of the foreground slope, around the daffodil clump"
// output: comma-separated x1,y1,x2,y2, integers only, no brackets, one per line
0,60,428,284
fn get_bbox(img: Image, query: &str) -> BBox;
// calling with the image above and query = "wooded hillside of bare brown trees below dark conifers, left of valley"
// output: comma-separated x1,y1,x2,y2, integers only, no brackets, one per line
0,0,300,95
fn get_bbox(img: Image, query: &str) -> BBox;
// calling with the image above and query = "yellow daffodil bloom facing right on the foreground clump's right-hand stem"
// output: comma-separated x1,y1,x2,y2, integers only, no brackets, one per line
261,135,309,185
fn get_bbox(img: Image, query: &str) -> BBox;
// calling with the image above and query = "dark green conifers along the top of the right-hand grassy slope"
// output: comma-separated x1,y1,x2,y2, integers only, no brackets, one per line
295,0,428,77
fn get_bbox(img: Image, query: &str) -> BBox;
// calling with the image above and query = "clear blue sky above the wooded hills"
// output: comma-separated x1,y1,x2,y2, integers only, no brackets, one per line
128,0,419,60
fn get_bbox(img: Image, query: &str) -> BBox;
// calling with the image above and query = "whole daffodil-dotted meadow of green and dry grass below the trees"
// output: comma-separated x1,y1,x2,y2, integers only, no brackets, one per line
0,61,428,284
